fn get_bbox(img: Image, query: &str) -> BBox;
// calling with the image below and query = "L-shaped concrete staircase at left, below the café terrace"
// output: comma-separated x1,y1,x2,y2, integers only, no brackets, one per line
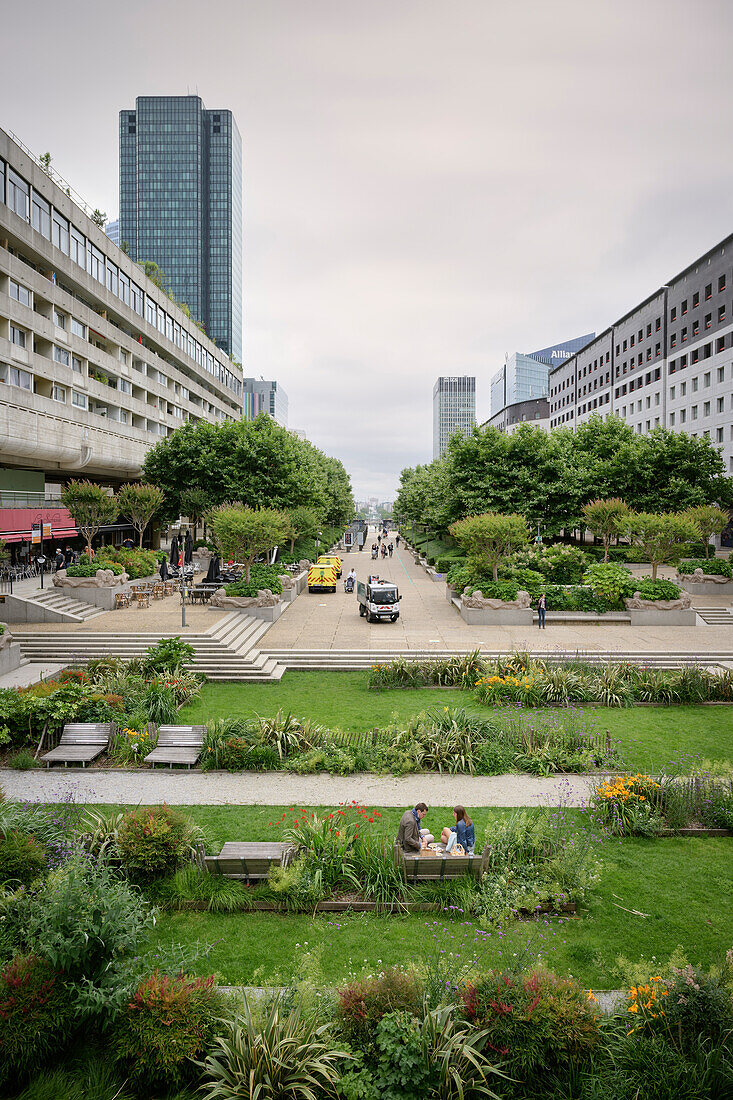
13,612,285,682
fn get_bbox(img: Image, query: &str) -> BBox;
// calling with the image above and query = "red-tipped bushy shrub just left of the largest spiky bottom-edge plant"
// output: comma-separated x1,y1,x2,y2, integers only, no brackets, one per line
114,972,225,1096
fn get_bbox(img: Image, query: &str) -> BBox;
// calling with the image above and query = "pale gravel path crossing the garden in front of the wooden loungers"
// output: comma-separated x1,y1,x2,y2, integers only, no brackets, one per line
0,768,593,806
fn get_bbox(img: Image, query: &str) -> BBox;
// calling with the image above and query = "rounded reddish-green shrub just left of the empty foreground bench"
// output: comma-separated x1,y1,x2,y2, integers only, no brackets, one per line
117,805,192,882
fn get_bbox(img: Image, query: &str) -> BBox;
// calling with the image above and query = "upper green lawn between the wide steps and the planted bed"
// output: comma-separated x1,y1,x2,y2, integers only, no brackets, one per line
180,672,733,771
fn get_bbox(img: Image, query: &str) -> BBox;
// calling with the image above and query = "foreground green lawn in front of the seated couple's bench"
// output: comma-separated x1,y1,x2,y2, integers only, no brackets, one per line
151,836,733,988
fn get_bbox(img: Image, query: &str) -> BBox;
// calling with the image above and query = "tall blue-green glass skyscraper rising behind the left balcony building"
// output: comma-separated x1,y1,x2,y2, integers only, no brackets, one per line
120,96,242,363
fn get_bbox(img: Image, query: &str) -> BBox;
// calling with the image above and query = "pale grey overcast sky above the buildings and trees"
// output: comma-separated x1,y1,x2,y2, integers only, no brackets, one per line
0,0,733,499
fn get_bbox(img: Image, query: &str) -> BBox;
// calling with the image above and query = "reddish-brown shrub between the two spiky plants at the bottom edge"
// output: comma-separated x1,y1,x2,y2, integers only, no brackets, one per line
336,967,423,1047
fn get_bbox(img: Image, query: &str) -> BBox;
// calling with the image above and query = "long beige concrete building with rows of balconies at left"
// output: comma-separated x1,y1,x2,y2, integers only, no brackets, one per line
0,123,242,494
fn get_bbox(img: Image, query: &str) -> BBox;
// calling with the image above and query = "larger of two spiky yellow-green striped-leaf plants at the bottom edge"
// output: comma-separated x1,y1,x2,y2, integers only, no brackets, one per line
198,997,349,1100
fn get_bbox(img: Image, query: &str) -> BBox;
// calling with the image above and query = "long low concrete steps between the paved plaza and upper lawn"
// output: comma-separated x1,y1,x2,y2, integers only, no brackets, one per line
262,642,733,672
